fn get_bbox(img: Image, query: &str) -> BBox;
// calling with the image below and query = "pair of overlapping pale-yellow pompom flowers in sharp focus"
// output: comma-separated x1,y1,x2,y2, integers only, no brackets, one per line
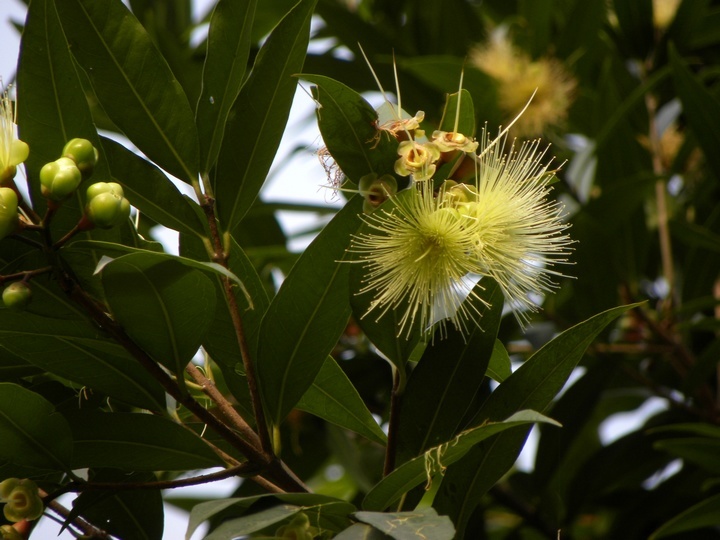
350,127,572,335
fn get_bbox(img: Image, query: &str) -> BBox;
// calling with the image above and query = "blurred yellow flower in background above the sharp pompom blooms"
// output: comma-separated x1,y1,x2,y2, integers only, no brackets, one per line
470,32,576,137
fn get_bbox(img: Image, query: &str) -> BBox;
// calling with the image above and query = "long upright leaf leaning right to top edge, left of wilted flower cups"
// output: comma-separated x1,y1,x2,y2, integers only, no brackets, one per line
214,0,316,231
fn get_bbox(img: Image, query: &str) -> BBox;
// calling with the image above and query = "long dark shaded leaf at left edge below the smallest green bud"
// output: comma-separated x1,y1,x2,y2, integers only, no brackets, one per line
0,310,165,411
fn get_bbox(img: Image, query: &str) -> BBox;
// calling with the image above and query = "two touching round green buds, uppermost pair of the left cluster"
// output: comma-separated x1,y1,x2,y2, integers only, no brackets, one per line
40,139,98,202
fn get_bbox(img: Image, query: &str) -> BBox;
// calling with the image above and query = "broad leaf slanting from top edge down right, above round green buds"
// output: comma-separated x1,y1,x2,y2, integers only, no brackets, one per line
58,0,198,183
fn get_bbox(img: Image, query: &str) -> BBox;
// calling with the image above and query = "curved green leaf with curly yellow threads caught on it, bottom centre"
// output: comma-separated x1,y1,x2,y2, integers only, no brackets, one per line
363,412,559,511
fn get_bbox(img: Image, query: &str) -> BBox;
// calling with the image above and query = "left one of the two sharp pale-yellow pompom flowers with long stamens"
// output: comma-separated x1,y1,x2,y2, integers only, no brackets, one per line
350,182,481,335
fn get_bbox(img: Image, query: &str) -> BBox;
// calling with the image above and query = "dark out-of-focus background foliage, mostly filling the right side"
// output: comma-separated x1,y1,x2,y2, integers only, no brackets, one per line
4,0,720,540
